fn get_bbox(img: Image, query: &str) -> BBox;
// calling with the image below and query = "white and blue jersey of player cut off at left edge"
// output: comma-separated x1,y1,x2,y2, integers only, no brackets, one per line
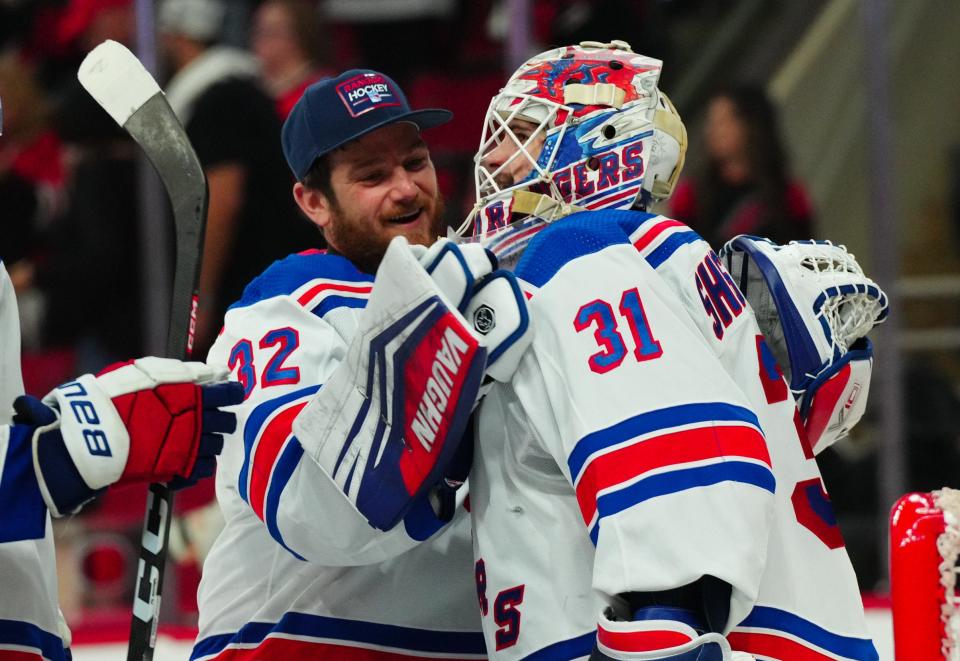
0,262,69,661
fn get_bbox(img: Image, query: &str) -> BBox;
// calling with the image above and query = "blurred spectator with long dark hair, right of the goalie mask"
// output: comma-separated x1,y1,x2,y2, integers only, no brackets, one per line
670,85,813,249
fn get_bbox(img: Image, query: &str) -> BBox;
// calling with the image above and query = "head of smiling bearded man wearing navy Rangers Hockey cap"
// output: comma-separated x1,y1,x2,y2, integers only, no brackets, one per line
283,69,452,273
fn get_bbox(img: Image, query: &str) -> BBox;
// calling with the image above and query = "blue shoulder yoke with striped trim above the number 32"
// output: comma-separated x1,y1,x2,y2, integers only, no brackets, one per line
230,250,373,310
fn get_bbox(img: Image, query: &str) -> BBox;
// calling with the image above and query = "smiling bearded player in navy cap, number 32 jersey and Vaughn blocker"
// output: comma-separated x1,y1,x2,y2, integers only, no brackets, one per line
192,70,528,660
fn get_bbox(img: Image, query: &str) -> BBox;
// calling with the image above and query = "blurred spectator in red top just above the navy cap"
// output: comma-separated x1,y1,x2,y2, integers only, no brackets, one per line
250,0,332,120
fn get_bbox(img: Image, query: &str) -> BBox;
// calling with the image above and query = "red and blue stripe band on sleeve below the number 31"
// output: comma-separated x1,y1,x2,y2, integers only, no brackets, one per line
567,402,776,543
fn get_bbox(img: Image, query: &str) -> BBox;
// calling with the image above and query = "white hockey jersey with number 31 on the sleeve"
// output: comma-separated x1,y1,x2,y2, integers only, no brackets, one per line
470,211,877,660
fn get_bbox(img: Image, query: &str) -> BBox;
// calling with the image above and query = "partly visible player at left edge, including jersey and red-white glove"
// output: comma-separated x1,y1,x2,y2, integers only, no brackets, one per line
0,255,242,661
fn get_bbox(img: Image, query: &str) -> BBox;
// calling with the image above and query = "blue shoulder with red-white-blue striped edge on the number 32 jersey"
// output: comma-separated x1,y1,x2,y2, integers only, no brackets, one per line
230,250,373,317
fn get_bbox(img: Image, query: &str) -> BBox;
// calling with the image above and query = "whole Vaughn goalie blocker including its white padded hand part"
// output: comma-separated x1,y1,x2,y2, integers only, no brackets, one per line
293,237,531,530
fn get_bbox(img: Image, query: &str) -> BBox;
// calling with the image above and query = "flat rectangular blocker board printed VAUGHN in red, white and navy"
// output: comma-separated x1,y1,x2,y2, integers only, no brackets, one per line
293,237,487,530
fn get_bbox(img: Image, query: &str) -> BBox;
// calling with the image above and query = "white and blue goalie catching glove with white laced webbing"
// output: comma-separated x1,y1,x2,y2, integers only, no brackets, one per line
720,235,888,453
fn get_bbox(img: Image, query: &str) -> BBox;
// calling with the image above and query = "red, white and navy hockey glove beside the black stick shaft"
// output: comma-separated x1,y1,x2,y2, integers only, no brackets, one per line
13,358,243,516
